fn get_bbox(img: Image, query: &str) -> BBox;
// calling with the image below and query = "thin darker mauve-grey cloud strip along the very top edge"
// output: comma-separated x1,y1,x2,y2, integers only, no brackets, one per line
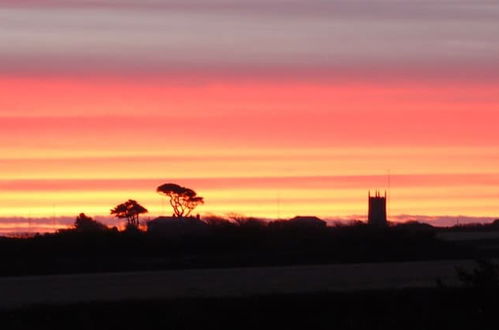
0,0,499,19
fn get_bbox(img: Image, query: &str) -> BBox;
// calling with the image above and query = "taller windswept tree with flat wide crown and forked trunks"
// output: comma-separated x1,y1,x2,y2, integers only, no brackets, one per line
156,183,204,217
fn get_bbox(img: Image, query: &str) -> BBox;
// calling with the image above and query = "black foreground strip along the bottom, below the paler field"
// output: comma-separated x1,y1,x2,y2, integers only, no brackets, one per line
0,289,499,330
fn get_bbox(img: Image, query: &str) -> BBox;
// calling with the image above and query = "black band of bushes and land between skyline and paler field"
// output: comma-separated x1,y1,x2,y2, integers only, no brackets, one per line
0,213,484,276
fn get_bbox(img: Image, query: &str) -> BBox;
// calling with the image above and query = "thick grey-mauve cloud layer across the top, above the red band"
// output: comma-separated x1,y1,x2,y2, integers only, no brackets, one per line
0,0,499,80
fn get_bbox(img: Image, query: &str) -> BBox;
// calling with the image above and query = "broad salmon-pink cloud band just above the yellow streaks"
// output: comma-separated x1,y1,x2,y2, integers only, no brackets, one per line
0,109,498,150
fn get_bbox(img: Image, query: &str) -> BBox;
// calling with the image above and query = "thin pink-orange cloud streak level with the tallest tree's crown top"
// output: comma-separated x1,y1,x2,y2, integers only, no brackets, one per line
0,173,499,191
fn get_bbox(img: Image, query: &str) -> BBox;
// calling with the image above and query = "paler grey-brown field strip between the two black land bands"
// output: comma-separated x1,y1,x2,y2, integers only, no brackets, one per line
0,260,474,308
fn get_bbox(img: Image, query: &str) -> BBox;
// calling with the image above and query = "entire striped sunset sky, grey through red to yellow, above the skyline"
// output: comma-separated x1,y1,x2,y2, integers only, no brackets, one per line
0,0,499,232
